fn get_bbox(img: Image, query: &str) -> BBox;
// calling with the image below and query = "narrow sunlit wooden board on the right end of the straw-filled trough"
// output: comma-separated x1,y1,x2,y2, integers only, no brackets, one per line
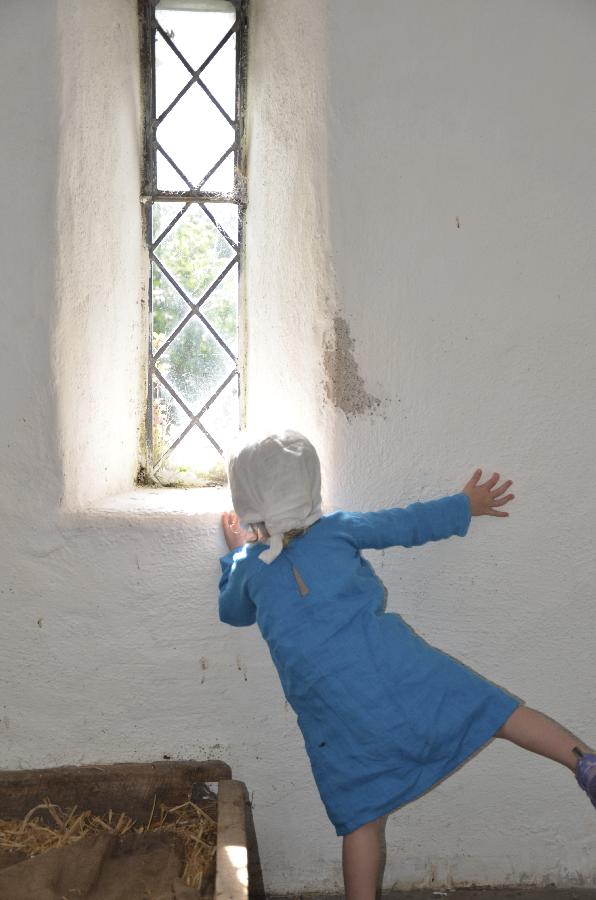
214,780,248,900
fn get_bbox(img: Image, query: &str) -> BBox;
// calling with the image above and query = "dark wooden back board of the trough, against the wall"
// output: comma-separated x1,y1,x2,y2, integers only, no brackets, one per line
0,760,231,819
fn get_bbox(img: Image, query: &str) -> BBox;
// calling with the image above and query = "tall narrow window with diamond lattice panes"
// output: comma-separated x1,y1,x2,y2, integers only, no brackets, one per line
140,0,247,485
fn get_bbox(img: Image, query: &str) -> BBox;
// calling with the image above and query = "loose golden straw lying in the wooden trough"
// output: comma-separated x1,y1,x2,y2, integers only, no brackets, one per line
0,799,217,889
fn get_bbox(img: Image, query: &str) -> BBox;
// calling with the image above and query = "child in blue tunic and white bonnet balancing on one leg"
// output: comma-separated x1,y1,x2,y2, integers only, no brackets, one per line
219,431,596,900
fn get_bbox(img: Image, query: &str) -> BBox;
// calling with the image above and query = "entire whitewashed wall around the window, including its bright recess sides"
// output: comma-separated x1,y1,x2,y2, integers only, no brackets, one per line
0,0,596,891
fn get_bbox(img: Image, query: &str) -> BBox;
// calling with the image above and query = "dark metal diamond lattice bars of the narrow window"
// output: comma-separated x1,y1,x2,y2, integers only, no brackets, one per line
139,0,249,484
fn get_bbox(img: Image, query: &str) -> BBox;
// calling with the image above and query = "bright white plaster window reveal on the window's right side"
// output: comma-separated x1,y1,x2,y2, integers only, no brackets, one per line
246,0,335,463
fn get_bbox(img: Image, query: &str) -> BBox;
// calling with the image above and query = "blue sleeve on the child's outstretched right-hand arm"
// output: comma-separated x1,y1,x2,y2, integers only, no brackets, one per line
346,494,471,550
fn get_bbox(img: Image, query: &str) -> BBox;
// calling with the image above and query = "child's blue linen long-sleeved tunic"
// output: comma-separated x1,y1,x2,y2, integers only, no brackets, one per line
219,494,520,835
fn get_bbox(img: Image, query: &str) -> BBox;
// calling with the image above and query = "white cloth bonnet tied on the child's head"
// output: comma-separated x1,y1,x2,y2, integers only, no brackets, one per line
228,431,321,563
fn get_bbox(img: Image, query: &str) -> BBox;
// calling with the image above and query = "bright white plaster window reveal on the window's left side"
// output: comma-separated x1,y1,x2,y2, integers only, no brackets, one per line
54,0,147,508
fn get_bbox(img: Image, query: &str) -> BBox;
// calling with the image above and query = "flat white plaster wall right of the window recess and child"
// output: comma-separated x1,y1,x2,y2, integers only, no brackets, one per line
325,0,596,885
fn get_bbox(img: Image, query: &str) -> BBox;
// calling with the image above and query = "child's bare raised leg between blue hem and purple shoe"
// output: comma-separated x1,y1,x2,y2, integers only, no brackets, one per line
495,706,594,772
